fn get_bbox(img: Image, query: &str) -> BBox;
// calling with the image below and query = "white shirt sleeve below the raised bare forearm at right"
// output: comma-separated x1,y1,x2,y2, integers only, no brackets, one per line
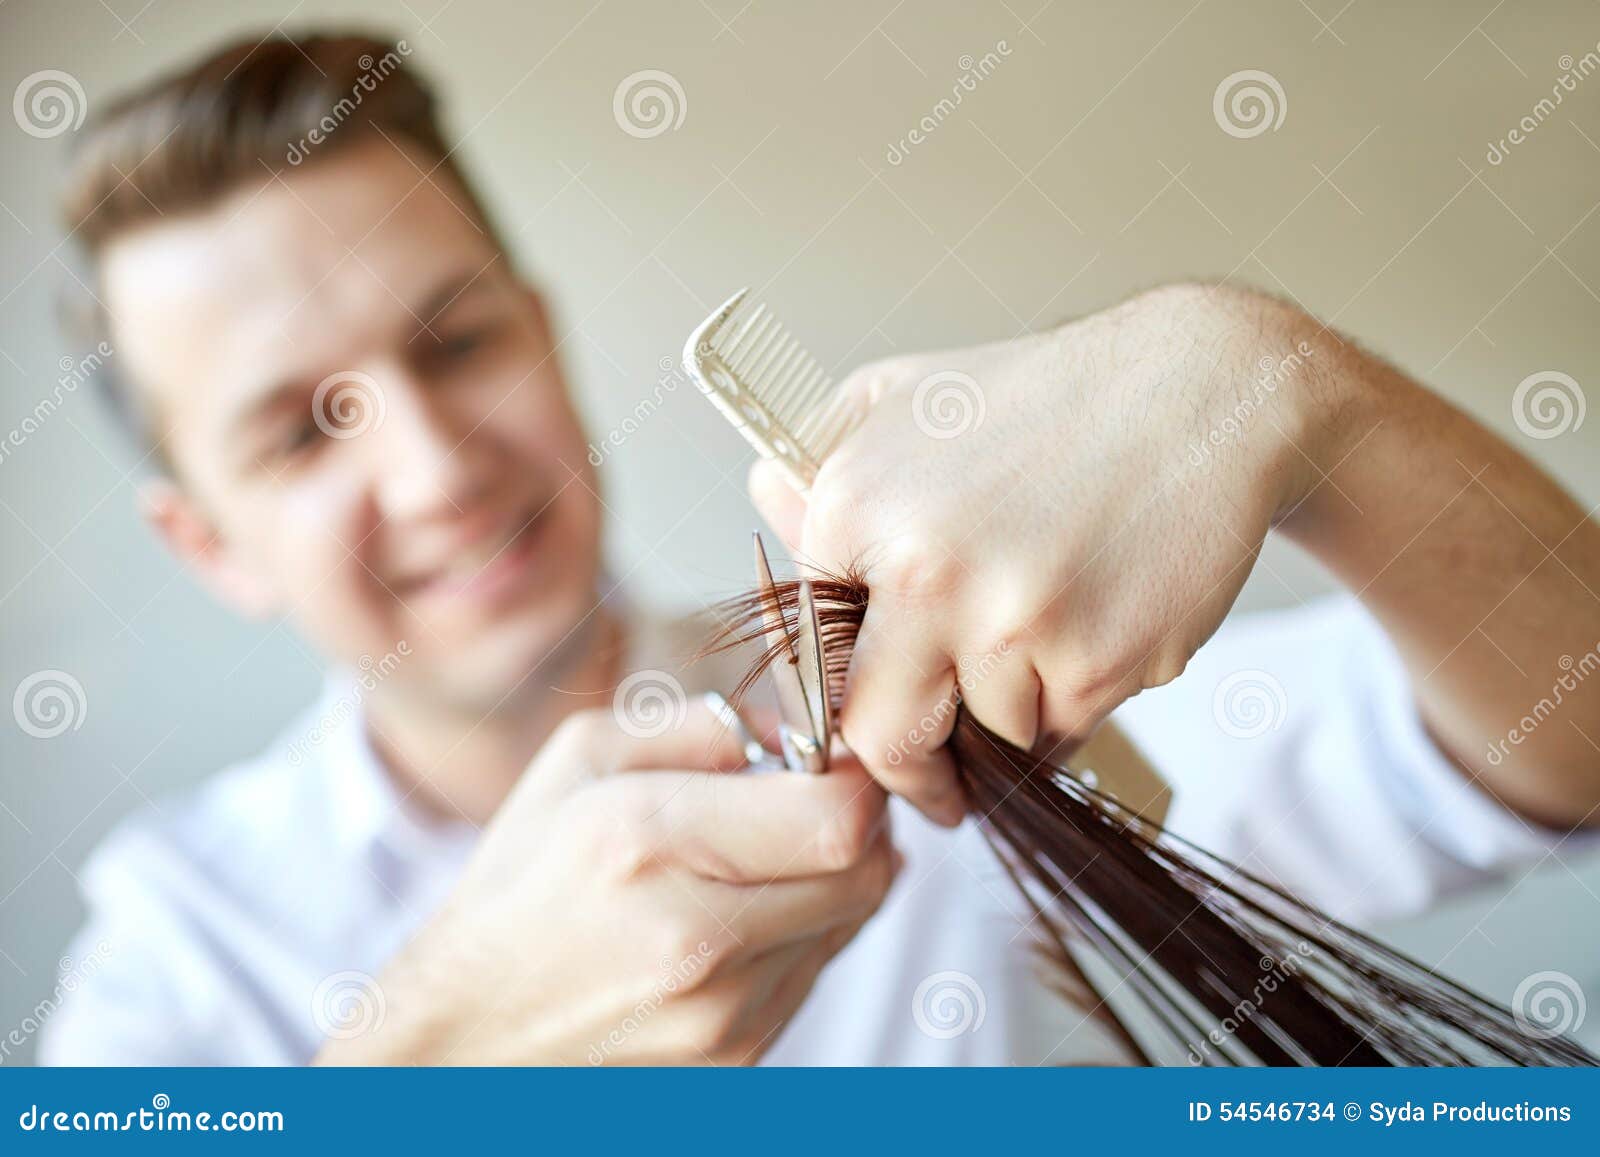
1117,597,1597,923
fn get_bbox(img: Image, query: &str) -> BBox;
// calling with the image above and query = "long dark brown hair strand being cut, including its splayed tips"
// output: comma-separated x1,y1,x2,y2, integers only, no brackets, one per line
702,573,1597,1064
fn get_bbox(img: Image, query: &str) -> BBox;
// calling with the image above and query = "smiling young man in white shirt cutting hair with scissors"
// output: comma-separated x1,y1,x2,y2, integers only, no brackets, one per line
45,37,1600,1064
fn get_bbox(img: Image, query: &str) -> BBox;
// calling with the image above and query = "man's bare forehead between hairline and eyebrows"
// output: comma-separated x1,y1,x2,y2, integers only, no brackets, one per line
102,139,498,422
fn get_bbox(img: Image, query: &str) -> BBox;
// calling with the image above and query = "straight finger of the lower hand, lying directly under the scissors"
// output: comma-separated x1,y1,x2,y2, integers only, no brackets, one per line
614,763,886,883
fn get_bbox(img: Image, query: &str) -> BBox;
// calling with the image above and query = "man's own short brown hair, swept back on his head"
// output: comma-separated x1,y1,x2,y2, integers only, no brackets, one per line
61,34,494,457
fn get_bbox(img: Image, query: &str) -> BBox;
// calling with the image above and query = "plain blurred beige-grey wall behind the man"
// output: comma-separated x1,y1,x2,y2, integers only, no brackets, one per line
0,0,1600,1056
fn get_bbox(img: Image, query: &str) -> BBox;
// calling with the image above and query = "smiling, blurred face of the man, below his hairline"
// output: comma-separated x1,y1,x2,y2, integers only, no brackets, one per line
104,141,600,709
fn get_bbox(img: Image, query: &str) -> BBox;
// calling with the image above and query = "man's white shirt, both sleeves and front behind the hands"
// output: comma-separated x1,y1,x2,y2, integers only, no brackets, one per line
42,599,1587,1066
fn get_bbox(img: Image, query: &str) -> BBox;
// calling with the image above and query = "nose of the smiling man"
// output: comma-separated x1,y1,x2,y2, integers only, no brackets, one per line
368,371,494,522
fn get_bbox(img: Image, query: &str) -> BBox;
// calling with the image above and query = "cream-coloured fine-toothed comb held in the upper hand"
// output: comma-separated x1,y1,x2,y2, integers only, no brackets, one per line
683,288,854,494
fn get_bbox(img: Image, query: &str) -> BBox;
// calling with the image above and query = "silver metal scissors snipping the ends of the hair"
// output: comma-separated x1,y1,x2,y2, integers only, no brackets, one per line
707,531,834,775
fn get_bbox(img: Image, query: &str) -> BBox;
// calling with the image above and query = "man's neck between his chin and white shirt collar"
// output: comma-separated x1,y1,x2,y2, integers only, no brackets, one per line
366,610,624,826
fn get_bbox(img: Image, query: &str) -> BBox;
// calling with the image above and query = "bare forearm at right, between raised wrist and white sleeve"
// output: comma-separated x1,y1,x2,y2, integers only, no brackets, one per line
1282,336,1600,826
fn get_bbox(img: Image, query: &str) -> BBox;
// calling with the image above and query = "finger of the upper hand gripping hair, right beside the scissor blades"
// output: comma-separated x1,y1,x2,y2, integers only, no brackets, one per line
838,599,966,826
